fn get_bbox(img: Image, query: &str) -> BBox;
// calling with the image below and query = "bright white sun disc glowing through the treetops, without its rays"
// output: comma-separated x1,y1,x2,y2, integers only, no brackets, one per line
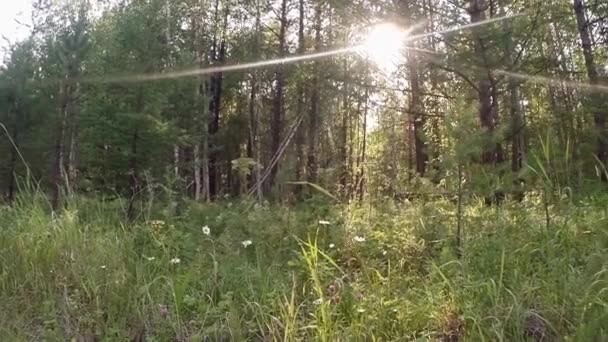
361,23,407,73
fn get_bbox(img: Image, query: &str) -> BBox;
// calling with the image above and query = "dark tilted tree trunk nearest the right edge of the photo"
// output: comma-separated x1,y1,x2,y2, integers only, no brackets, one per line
573,0,608,167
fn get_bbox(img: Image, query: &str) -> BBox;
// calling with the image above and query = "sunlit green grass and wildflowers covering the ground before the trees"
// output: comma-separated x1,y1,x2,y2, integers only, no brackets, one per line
0,195,608,341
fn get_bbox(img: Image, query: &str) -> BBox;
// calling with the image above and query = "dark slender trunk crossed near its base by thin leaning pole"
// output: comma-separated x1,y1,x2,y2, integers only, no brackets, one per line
265,0,289,193
